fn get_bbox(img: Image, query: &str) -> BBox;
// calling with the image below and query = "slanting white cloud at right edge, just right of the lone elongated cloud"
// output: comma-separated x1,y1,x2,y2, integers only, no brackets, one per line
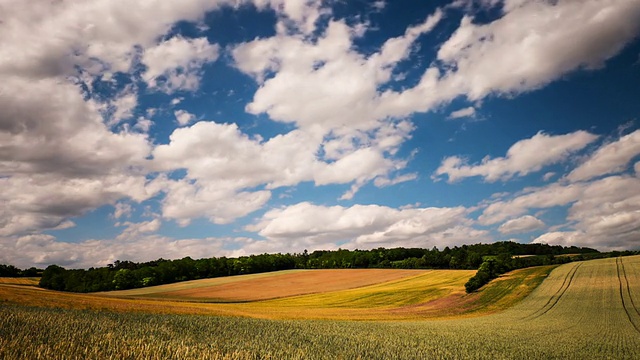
566,130,640,181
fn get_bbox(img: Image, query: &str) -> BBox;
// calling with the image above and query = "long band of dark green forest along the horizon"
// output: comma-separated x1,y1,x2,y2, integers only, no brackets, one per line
0,241,633,292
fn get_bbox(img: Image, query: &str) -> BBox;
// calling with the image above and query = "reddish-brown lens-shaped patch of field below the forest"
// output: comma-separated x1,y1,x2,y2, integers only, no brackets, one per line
141,269,429,302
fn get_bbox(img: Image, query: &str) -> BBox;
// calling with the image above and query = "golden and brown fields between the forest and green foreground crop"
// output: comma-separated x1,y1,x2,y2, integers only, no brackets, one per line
0,267,552,320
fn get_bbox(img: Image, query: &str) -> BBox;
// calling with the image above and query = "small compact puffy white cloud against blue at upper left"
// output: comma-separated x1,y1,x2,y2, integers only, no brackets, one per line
142,36,219,93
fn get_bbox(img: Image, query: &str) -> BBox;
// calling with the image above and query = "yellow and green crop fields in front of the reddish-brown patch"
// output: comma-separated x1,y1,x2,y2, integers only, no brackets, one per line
0,256,640,359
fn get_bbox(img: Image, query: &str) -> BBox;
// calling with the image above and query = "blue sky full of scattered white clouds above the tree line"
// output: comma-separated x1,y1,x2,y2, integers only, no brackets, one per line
0,0,640,268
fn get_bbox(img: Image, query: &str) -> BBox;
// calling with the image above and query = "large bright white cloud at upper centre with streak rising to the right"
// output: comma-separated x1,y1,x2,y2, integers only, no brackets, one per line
233,11,442,134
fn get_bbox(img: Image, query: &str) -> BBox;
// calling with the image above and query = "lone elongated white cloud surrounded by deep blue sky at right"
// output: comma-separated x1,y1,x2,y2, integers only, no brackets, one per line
434,131,598,182
